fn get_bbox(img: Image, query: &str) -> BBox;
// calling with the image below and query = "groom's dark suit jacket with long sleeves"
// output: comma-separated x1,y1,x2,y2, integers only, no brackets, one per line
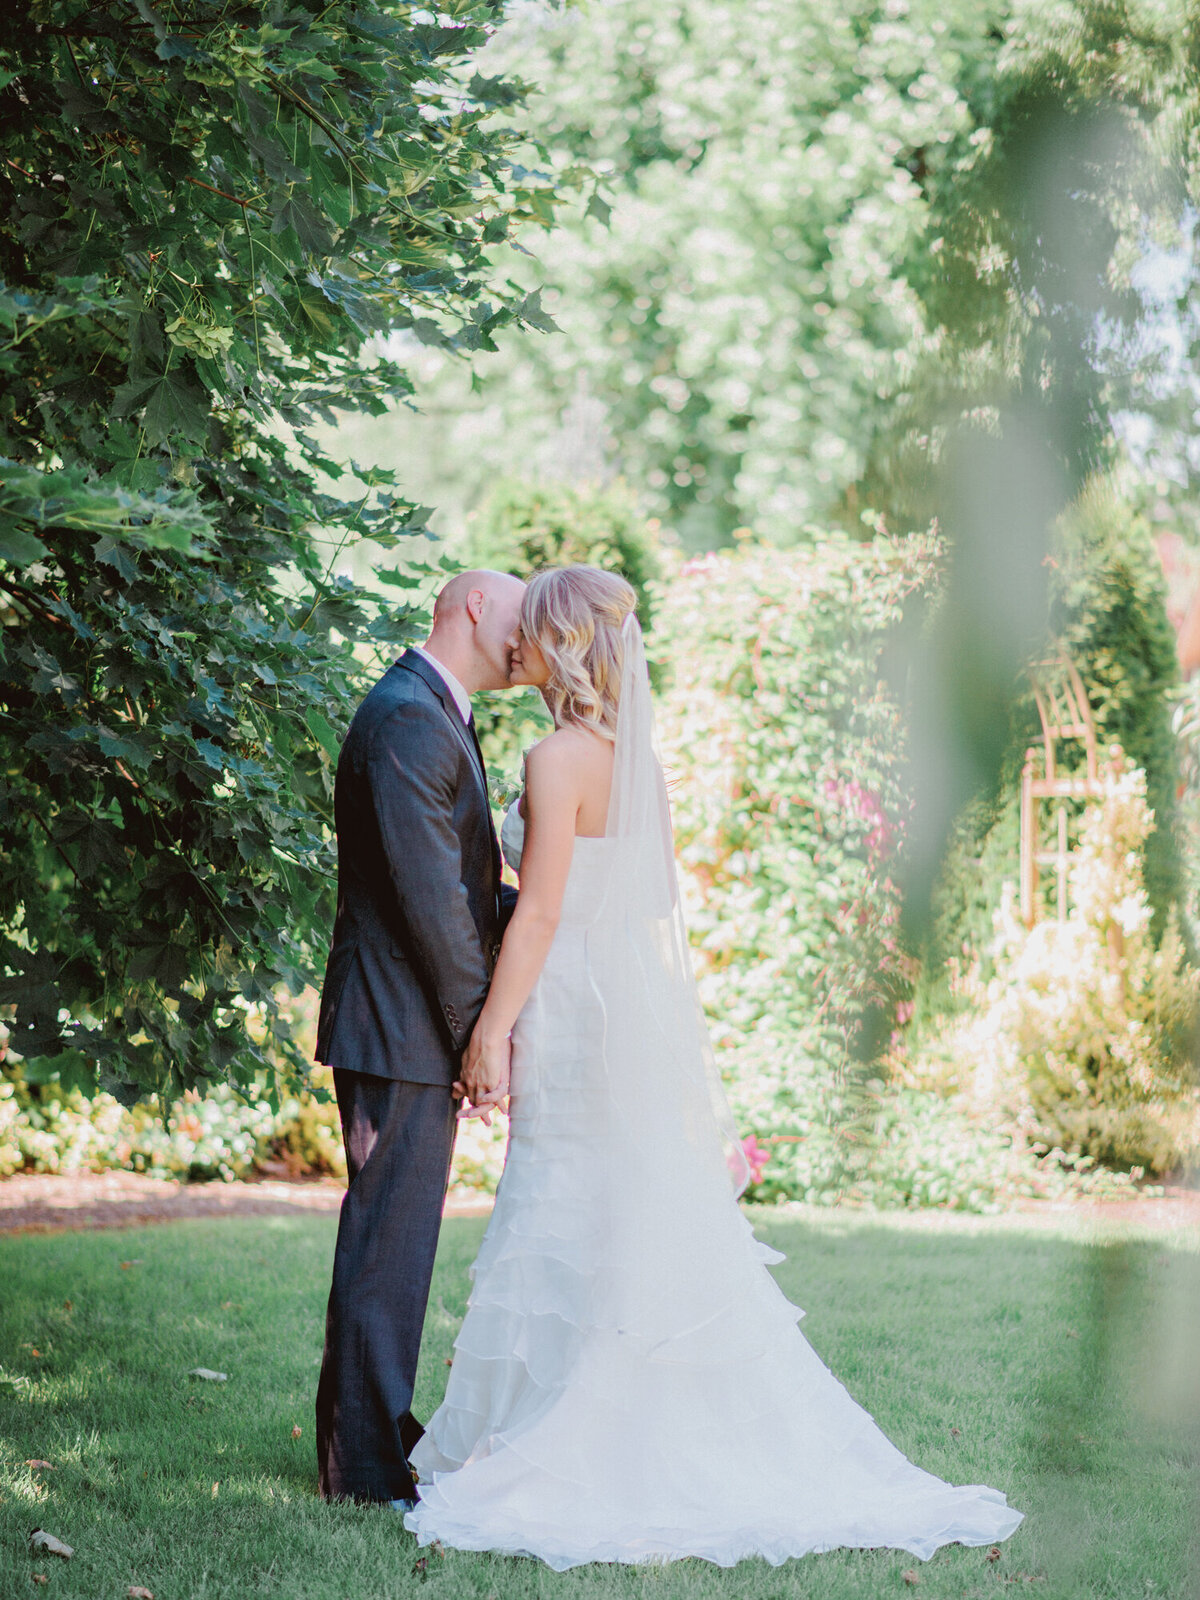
317,651,507,1085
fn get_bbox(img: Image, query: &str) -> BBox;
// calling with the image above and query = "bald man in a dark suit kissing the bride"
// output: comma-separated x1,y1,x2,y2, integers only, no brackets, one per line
317,571,525,1506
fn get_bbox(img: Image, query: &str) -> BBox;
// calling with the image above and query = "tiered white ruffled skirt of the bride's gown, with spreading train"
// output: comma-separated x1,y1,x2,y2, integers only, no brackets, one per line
405,933,1021,1571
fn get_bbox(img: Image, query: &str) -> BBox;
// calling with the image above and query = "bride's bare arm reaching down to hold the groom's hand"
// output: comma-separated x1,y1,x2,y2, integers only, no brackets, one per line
462,734,582,1106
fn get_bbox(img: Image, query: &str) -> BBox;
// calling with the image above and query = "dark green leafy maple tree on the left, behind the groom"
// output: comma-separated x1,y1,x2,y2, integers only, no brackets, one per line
0,0,572,1099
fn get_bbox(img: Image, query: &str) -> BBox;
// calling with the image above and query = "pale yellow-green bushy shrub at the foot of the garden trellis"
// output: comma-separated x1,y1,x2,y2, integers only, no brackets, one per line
915,768,1200,1173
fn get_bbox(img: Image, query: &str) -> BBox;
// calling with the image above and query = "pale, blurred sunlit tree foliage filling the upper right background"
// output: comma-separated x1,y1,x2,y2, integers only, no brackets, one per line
387,0,1197,549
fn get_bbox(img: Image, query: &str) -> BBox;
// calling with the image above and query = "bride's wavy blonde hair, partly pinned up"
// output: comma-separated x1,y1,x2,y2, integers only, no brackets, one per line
522,566,637,739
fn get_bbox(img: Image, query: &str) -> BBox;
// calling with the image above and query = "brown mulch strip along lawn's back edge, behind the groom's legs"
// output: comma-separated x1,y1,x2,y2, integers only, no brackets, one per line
0,1173,491,1234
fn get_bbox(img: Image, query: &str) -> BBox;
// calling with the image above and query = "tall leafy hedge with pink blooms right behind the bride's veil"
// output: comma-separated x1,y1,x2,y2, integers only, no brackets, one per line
654,534,938,1194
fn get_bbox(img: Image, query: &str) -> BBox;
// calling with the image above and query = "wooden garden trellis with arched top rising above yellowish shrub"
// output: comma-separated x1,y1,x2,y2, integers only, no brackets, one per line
1021,651,1102,928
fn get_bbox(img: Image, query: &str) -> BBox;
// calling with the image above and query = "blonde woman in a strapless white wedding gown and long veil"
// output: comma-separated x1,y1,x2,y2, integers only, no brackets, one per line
405,566,1021,1571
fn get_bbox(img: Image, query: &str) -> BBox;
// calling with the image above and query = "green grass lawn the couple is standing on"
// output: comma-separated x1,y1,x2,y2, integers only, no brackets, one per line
0,1213,1200,1600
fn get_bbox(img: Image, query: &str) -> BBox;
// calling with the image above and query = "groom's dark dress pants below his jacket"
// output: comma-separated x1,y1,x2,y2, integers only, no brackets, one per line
317,1067,458,1501
